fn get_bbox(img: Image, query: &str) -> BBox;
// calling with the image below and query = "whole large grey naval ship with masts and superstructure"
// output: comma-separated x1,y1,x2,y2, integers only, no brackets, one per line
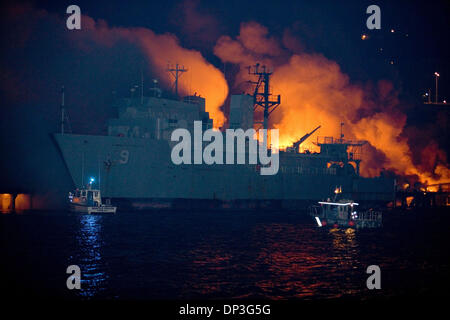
54,65,395,210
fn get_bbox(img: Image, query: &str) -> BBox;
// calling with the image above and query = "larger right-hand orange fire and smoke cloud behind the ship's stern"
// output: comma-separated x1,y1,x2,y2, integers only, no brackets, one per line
215,23,450,183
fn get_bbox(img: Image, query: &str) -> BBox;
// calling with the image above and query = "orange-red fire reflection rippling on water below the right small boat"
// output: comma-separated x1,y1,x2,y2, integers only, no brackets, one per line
256,225,358,299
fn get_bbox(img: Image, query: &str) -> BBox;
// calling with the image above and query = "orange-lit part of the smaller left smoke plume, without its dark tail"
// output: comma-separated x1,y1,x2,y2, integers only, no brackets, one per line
75,16,228,128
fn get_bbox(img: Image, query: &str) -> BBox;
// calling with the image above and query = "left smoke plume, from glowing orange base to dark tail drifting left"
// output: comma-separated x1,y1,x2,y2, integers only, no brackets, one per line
2,4,228,127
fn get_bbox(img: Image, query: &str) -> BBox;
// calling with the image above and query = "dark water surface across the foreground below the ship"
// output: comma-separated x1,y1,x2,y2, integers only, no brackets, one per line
0,209,450,299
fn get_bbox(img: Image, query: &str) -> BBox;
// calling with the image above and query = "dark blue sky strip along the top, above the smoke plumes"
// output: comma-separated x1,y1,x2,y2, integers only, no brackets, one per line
29,0,450,99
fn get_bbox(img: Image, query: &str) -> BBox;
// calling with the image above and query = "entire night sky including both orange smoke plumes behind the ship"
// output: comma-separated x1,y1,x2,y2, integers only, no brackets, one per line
0,0,450,200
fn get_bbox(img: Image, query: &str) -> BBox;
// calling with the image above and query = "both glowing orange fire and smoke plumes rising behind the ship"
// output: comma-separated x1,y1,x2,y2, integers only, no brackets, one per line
5,7,450,184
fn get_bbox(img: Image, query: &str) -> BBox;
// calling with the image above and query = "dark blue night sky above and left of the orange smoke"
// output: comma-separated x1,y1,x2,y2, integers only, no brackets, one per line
0,0,450,208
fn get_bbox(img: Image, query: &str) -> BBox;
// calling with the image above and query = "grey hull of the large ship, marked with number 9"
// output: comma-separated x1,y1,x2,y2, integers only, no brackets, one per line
54,134,394,209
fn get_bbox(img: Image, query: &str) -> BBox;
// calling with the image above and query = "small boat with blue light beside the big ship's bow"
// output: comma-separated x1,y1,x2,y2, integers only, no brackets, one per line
69,185,117,214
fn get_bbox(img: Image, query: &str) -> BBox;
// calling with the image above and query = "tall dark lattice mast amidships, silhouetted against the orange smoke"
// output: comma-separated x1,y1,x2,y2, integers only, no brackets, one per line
248,63,281,129
